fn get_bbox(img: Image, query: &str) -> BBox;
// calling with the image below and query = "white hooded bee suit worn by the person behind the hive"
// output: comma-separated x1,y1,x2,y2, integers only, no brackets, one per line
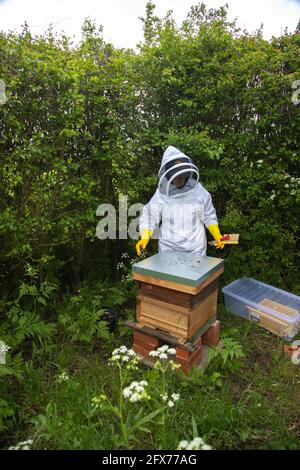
139,146,218,256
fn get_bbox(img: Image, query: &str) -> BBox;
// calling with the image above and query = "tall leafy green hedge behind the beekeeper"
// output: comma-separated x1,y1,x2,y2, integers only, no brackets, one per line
0,2,300,348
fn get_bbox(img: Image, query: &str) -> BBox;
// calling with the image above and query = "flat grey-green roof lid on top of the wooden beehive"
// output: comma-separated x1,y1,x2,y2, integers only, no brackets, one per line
132,251,224,287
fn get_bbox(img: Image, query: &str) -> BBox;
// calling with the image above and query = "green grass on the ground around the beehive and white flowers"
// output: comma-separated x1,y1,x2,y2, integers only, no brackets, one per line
1,305,300,449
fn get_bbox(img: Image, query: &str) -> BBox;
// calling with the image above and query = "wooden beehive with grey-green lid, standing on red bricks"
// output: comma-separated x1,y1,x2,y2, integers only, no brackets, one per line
133,251,224,339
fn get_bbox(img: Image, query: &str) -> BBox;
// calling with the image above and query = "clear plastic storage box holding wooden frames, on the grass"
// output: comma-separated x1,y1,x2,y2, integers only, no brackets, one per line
222,278,300,340
